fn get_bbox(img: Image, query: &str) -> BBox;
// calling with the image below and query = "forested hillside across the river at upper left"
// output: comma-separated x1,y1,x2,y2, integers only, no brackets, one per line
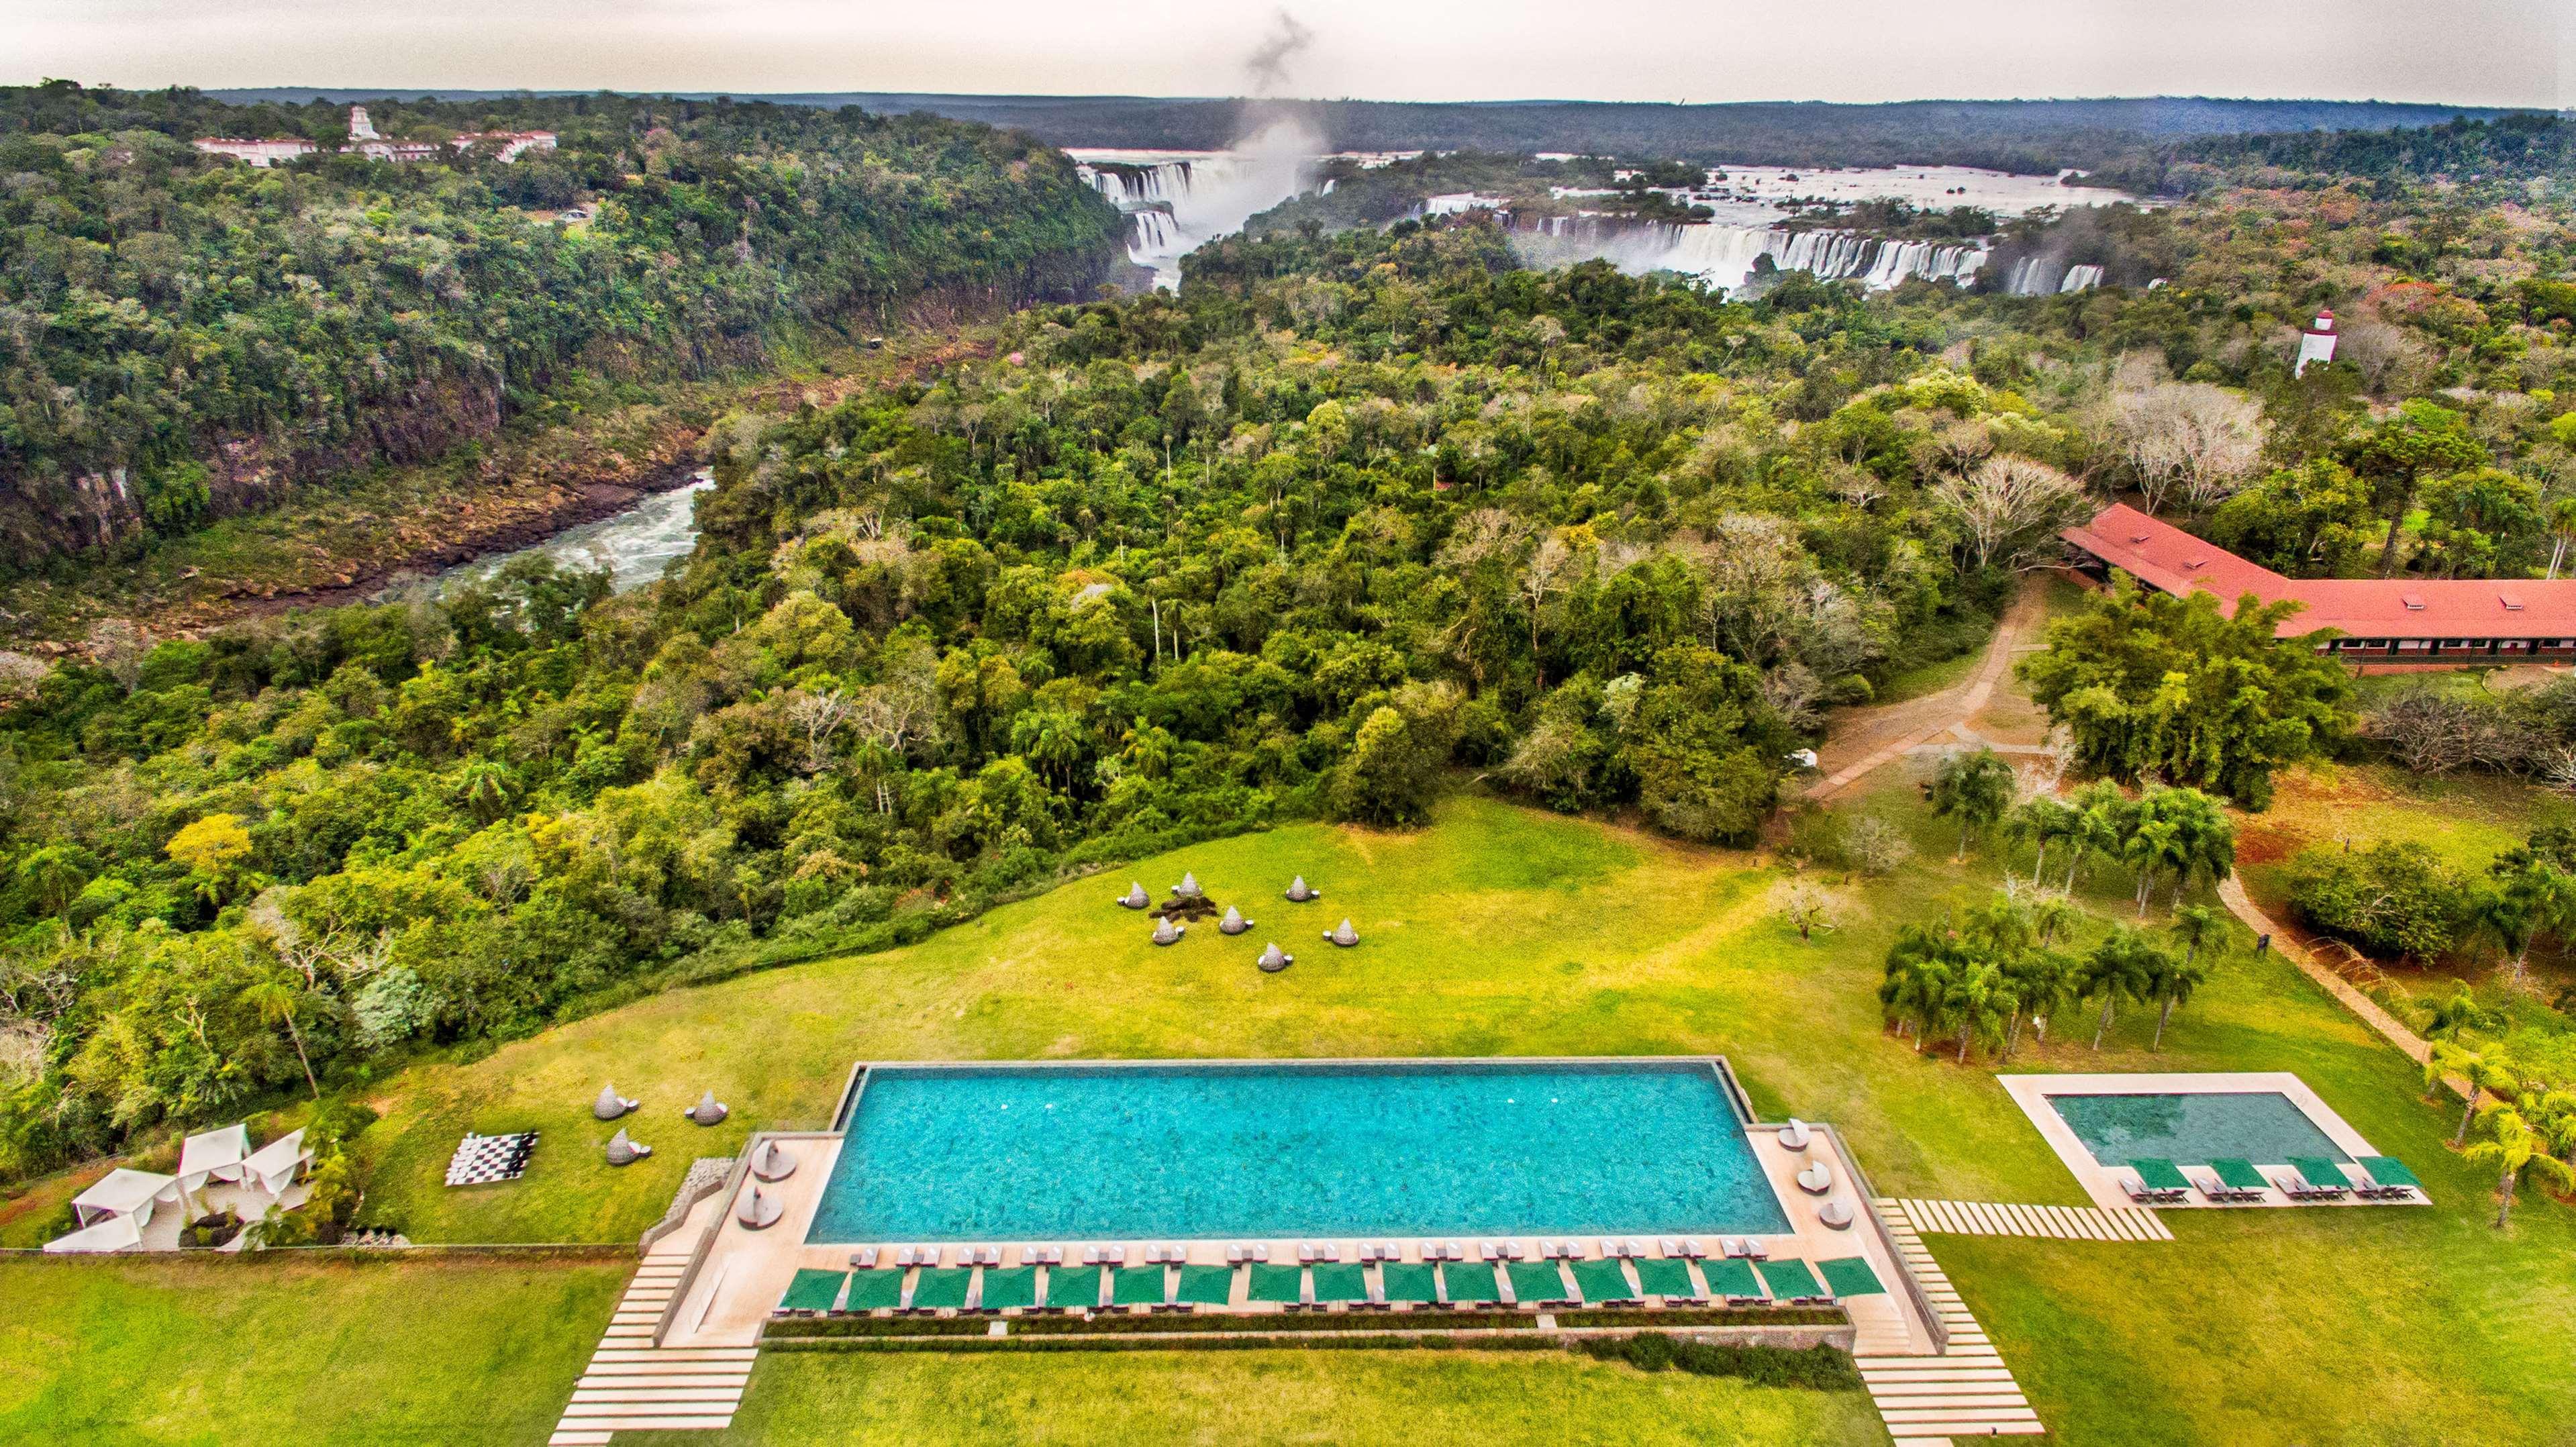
0,83,1121,564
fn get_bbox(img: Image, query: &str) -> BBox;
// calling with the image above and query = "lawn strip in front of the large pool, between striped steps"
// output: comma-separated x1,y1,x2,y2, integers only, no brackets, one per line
618,1352,1888,1447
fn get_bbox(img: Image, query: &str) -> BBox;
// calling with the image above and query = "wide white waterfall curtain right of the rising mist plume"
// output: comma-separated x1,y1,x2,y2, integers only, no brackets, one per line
1512,216,1986,291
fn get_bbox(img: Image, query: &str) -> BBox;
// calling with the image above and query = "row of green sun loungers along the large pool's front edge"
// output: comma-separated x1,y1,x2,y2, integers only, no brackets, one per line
775,1256,1885,1315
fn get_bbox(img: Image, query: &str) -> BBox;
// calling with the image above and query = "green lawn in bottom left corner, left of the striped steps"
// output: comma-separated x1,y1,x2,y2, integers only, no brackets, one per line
0,1256,634,1447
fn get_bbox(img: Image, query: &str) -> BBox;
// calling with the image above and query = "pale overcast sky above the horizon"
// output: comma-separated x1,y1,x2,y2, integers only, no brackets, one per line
0,0,2576,105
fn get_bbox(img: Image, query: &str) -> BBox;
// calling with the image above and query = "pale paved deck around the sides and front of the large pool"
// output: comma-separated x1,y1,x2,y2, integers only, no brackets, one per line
660,1125,1940,1354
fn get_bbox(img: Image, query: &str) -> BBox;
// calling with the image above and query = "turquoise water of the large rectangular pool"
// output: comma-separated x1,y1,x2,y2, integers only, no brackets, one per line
806,1061,1788,1241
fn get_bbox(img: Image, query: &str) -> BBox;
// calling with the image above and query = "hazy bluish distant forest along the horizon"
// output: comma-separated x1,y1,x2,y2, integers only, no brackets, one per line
216,90,2506,175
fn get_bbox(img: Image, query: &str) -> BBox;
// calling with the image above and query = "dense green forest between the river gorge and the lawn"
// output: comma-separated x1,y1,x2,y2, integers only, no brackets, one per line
0,110,2576,1174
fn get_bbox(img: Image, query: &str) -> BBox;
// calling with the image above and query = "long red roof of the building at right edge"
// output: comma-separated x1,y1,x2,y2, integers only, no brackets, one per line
2059,502,2576,638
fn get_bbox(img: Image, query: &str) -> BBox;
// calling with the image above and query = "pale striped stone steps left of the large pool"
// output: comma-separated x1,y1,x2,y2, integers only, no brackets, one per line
546,1213,760,1447
